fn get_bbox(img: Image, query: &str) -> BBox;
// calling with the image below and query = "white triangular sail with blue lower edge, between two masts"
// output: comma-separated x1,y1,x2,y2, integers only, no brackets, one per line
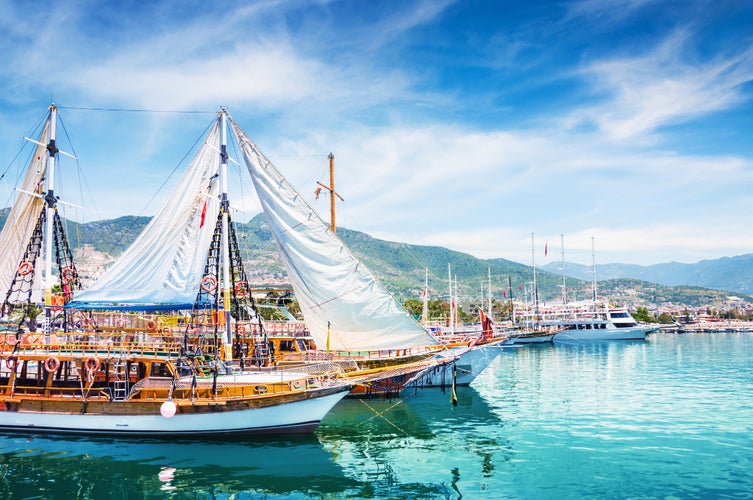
70,120,220,309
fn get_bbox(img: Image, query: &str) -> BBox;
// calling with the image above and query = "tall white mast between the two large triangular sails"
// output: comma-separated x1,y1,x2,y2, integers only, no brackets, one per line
220,109,233,375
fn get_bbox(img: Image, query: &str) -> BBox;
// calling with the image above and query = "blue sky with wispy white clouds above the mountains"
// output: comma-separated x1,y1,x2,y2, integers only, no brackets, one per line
0,0,753,265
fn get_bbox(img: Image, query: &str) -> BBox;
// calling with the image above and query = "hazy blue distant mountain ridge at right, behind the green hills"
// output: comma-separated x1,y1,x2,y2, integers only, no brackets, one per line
542,254,753,294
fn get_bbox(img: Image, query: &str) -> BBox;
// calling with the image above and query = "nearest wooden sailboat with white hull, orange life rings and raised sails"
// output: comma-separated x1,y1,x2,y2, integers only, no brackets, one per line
0,106,351,437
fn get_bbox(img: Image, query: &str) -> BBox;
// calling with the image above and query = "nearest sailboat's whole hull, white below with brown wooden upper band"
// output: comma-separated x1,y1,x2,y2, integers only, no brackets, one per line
0,386,349,437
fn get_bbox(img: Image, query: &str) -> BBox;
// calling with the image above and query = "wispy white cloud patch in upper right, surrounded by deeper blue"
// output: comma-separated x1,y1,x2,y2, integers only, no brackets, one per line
567,31,753,140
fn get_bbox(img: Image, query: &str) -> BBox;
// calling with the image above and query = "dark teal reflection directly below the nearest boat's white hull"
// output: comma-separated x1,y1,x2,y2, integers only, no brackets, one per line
0,435,356,498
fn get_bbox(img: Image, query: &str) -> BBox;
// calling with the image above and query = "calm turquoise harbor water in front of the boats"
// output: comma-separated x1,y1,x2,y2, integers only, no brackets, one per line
0,333,753,499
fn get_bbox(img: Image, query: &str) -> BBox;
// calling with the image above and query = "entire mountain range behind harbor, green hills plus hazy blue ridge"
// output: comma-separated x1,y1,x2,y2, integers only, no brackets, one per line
0,208,753,307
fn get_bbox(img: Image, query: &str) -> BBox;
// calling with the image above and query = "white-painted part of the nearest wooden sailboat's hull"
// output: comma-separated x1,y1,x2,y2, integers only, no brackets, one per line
0,387,348,437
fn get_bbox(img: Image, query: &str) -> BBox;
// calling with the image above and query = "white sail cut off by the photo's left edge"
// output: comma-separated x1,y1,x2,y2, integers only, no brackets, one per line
0,115,50,299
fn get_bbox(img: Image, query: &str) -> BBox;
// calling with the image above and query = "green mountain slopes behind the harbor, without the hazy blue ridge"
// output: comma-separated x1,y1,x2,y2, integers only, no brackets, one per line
0,208,753,308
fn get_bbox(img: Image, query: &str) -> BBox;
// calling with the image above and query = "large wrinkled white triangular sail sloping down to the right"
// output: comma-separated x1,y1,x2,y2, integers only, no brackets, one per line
231,121,437,351
